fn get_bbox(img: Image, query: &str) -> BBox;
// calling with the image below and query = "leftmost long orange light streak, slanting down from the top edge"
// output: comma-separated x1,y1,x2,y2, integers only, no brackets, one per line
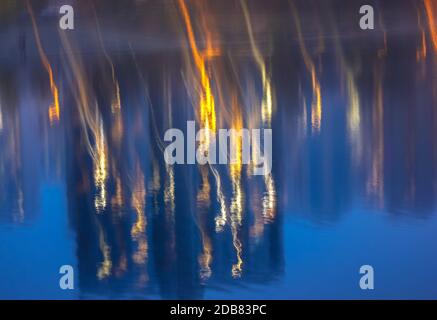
26,0,60,125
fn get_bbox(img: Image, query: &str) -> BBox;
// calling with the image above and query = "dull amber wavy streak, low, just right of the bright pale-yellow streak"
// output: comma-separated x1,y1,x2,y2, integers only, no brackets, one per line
131,163,149,265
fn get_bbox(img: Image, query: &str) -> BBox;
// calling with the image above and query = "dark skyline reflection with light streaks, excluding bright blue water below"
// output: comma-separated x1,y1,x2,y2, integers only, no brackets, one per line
0,0,437,299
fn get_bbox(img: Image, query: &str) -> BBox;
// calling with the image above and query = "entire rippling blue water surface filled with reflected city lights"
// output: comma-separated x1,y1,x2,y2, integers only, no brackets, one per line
0,0,437,299
